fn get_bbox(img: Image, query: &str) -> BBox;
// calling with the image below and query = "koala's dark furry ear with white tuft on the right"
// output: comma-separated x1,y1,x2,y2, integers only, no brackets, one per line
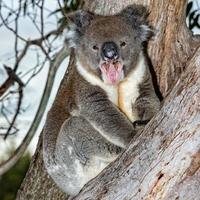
120,4,154,42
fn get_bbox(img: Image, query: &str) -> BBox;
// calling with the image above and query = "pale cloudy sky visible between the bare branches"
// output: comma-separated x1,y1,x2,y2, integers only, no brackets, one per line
0,0,199,160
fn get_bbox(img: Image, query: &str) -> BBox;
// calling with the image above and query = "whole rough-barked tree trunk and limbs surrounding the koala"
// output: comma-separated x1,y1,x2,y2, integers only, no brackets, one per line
17,0,200,200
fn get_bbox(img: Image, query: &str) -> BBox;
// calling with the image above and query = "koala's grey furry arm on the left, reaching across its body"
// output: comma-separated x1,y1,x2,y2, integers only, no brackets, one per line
79,90,135,148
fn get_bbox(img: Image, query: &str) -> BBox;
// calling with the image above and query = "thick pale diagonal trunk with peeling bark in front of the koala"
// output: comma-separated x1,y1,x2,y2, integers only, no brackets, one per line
74,48,200,200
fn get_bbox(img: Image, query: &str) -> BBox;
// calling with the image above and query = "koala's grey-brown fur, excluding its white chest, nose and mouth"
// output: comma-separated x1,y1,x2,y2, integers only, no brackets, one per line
43,5,160,196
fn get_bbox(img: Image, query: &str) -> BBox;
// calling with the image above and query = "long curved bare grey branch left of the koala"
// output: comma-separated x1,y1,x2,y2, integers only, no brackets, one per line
0,47,70,176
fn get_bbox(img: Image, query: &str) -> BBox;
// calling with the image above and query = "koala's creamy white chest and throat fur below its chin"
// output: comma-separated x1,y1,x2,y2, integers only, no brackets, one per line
77,54,146,122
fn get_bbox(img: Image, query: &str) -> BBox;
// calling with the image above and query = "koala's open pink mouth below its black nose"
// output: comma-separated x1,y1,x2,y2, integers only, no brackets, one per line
100,60,123,85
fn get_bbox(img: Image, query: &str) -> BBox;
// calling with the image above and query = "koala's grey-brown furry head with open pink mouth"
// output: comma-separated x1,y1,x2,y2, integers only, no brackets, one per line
66,5,153,85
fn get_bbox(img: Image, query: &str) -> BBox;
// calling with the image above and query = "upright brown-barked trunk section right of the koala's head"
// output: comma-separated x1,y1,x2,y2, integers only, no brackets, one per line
148,0,200,97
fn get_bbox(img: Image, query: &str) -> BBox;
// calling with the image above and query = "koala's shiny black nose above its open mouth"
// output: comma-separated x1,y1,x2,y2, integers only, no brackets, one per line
102,42,118,59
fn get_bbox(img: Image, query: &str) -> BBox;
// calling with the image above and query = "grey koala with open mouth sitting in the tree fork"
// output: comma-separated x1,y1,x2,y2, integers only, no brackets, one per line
43,5,160,196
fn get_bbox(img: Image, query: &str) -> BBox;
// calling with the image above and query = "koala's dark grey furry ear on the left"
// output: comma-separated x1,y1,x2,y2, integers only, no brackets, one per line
67,10,94,32
